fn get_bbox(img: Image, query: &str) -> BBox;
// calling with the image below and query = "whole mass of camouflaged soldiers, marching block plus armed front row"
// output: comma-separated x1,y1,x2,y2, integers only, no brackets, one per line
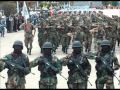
0,0,120,89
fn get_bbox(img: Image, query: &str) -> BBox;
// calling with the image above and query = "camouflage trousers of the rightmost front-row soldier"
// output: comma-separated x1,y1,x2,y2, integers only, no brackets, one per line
96,76,114,89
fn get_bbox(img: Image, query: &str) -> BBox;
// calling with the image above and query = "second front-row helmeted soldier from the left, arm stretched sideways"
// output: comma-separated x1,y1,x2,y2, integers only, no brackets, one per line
30,42,62,89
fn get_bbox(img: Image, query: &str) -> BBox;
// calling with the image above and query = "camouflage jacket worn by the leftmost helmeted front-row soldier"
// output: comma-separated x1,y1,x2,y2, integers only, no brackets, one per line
0,53,31,85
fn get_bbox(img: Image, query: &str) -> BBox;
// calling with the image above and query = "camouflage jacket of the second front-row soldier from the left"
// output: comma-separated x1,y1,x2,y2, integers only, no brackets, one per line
30,56,62,84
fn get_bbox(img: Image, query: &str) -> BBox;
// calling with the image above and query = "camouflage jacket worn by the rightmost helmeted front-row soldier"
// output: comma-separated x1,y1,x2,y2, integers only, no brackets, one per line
95,52,120,77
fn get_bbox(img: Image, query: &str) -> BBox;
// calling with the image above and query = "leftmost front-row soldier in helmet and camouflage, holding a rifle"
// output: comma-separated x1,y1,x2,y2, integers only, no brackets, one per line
0,40,30,89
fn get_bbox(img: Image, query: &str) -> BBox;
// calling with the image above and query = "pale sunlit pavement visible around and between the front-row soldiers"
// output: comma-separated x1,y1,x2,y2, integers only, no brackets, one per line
0,31,120,89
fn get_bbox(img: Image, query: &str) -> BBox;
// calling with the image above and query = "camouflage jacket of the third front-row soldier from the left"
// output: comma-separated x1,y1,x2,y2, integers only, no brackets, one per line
62,54,91,83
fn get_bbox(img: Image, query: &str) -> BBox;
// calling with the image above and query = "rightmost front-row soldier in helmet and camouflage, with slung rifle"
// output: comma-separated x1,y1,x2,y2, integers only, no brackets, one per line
95,40,120,89
